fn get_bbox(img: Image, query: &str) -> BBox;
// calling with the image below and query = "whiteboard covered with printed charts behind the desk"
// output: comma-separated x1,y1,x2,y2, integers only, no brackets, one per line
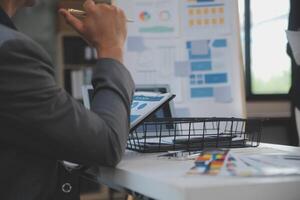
116,0,245,117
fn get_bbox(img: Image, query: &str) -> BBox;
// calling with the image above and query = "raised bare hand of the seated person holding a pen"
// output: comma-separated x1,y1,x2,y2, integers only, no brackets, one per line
59,0,127,62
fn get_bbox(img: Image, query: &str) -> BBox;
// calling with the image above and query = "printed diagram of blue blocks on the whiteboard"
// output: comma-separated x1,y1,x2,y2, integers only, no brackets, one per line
175,38,232,102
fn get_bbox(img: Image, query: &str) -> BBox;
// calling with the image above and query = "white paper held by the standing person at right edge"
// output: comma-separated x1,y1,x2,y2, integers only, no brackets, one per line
286,30,300,65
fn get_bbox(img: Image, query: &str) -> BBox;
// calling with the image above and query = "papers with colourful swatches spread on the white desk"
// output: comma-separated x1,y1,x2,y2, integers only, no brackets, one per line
188,150,300,177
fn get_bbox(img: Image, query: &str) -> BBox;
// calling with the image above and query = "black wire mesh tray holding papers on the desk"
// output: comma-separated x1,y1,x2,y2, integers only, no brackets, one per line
127,118,262,153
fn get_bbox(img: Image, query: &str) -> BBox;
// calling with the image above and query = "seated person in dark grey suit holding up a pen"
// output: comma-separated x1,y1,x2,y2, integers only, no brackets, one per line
0,0,134,200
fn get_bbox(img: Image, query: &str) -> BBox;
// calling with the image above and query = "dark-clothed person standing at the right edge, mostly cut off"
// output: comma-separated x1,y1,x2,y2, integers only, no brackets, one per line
288,0,300,146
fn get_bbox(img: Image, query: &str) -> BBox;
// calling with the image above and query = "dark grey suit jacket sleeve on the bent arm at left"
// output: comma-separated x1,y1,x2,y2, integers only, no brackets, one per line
0,36,134,166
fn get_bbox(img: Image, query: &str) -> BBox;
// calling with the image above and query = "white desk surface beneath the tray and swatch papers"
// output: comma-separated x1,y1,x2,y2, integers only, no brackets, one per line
98,144,300,200
